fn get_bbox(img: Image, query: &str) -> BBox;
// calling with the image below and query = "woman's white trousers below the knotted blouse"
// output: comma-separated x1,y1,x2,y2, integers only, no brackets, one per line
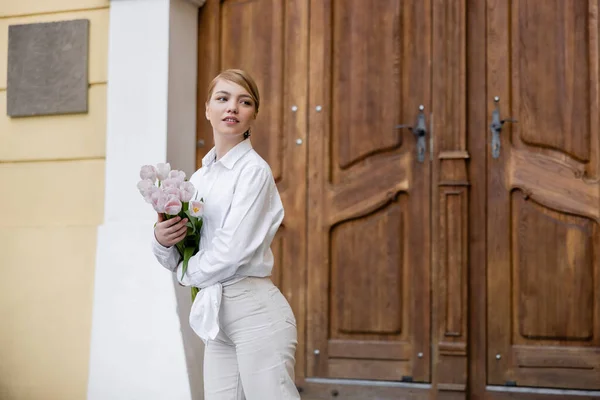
204,277,300,400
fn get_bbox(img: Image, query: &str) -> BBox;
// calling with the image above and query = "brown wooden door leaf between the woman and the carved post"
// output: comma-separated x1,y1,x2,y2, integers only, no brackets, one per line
306,0,431,382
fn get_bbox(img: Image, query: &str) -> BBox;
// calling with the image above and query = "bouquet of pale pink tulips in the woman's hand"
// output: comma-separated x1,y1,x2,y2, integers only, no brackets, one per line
137,163,204,301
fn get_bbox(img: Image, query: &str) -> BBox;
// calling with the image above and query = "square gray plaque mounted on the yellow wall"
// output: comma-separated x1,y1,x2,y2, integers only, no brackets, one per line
6,20,89,117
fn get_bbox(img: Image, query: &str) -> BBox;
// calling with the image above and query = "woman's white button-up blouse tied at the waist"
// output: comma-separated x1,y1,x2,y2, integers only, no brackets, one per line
152,139,284,341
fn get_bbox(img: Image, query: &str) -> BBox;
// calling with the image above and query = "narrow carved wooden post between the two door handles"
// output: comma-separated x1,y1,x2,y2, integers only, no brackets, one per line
431,0,474,398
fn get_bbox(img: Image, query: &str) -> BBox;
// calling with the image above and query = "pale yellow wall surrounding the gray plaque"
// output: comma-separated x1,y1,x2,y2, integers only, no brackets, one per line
0,0,109,400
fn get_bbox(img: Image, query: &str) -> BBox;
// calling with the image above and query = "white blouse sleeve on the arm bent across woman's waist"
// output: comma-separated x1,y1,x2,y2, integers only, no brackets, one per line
177,167,278,288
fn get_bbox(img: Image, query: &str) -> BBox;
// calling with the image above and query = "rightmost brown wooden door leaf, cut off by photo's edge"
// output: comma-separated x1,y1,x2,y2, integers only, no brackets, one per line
486,0,600,389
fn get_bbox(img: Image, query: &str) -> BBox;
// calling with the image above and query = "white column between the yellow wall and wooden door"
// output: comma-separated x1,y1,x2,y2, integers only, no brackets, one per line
88,0,201,400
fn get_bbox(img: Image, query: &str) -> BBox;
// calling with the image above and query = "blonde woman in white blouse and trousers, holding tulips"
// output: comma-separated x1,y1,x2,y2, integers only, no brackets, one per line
153,70,300,400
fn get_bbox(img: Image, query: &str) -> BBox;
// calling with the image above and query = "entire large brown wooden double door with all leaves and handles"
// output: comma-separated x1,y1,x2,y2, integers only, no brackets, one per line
198,0,600,399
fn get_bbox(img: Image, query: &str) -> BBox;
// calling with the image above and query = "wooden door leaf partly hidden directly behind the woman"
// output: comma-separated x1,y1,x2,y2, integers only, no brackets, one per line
197,0,308,380
